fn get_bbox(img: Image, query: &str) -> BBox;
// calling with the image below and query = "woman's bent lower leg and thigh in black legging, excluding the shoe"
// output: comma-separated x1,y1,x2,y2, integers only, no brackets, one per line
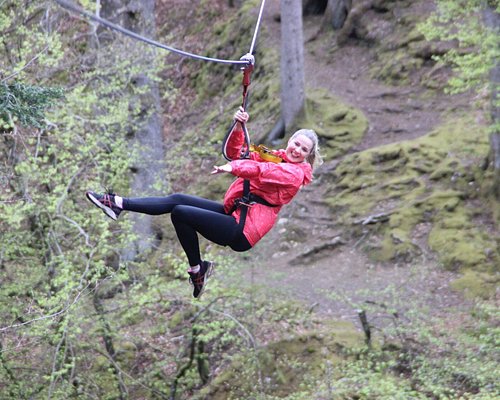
171,205,251,266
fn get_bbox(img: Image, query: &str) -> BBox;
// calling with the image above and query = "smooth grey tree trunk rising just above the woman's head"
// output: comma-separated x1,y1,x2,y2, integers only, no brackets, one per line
280,0,305,129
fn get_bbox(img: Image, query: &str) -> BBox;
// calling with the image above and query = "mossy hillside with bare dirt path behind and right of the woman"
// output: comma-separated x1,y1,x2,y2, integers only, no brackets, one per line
150,0,500,399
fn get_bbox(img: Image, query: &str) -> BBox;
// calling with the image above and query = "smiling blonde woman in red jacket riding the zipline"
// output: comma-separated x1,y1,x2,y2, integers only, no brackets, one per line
87,108,321,298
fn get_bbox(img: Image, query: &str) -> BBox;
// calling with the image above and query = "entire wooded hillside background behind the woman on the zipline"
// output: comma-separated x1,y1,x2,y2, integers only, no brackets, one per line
0,0,500,400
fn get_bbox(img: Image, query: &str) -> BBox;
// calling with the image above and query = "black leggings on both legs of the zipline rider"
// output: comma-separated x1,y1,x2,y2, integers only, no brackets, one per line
123,193,252,266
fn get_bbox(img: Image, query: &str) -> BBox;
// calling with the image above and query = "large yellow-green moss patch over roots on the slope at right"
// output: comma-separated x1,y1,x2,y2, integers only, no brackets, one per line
326,118,500,294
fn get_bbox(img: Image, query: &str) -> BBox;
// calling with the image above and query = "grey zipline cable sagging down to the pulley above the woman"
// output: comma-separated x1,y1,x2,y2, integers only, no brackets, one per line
55,0,249,66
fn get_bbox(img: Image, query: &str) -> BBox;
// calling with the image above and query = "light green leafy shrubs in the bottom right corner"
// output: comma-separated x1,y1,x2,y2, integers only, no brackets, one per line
314,263,499,399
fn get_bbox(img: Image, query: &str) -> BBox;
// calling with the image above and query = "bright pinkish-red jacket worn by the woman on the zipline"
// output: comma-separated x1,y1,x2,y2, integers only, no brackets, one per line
224,125,312,247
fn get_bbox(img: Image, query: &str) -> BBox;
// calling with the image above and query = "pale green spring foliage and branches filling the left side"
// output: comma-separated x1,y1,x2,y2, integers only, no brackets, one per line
0,1,175,399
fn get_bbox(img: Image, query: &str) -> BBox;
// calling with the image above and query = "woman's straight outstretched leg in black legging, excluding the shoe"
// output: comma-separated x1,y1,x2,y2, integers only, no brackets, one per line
123,193,224,215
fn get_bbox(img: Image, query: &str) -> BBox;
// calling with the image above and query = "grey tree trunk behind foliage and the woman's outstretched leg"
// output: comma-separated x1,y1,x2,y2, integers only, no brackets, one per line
101,0,164,259
